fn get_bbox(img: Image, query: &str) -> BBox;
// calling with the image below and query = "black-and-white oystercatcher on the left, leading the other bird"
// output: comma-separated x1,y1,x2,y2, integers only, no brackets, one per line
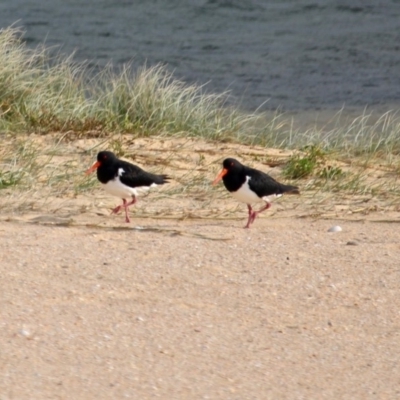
86,151,169,222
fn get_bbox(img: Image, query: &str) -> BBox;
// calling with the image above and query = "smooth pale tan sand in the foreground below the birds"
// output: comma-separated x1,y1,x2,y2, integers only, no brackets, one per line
0,210,400,400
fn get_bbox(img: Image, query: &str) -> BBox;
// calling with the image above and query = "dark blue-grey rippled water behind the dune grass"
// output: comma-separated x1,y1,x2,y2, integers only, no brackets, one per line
0,0,400,117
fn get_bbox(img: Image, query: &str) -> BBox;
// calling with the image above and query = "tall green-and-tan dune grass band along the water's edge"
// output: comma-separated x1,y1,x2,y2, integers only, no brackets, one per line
0,28,400,153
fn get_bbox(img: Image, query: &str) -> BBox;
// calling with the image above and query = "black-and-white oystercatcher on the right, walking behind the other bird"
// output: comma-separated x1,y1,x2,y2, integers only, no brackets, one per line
213,158,300,228
